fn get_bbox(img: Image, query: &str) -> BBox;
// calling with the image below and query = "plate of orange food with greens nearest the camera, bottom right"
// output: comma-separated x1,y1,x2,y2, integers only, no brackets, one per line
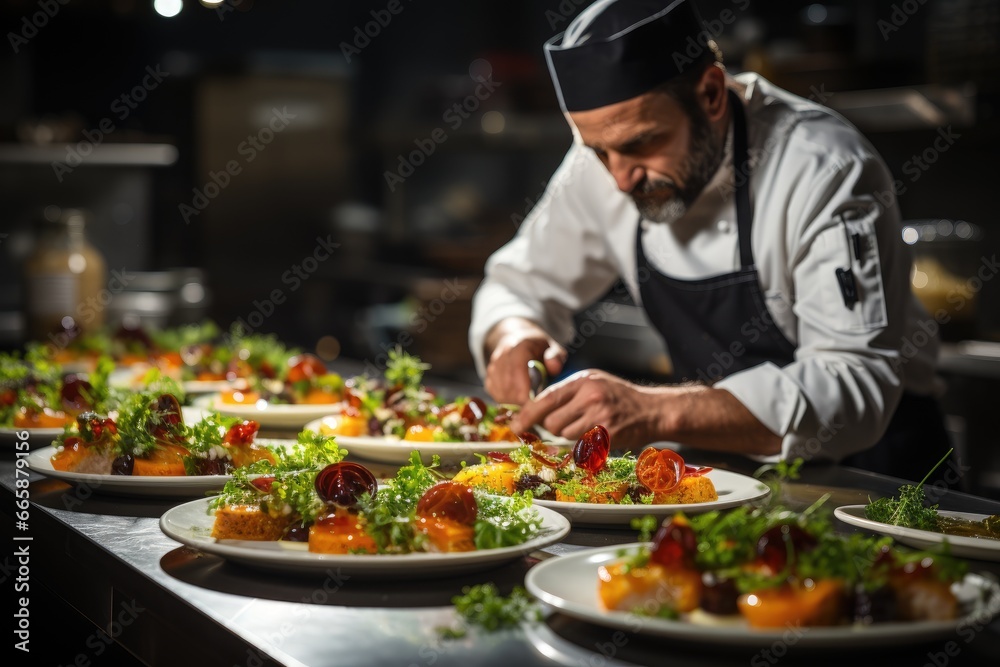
527,470,997,643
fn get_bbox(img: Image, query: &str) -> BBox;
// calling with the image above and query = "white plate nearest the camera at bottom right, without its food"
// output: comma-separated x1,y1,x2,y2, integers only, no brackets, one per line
524,544,1000,649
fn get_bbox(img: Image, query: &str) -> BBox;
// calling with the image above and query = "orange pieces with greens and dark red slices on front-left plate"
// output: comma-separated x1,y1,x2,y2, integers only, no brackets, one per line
211,452,556,555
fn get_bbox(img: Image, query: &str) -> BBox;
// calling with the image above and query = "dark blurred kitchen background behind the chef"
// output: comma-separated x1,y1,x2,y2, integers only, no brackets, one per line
0,0,1000,491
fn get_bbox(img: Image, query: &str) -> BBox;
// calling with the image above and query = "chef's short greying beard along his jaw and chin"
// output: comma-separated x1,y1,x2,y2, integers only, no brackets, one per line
630,108,725,223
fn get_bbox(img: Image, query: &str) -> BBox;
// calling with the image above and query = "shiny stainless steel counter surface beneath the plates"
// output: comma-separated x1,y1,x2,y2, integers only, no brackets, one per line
0,440,1000,667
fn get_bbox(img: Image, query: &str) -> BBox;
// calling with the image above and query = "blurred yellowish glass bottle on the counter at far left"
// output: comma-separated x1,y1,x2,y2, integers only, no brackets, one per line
23,207,111,347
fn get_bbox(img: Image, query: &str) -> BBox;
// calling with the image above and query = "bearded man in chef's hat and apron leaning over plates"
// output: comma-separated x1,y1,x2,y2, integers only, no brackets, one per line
469,0,948,480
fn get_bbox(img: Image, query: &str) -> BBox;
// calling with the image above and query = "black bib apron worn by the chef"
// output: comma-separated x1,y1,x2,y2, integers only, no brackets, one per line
635,90,949,481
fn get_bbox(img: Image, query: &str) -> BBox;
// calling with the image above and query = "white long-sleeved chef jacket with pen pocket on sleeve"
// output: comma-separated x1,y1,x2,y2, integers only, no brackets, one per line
469,73,938,460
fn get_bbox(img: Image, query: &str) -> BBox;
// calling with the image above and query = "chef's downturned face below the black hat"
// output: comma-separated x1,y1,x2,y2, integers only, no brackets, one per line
570,78,723,222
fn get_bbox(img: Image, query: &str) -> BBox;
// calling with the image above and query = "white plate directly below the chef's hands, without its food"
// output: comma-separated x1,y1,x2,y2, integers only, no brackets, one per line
536,470,770,527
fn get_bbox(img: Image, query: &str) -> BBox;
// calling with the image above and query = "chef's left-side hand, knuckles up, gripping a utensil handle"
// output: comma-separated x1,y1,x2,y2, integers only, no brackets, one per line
483,317,566,405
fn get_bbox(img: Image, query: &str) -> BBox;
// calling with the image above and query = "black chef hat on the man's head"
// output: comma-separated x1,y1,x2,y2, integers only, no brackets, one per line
545,0,708,111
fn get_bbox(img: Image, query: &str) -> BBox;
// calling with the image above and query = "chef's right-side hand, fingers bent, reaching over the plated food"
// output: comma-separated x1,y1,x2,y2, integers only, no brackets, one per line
511,370,665,447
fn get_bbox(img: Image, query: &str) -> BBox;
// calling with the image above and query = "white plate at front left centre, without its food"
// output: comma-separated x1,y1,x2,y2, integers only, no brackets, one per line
160,498,570,579
